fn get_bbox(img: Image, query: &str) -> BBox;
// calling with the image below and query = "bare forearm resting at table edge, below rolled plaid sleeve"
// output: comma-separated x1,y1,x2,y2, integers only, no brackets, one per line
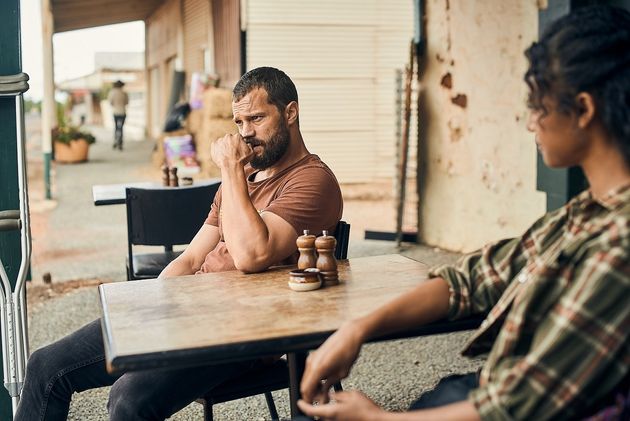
354,278,450,340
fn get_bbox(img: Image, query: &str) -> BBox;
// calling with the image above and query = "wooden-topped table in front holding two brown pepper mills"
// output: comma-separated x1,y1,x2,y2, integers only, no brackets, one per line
99,255,478,414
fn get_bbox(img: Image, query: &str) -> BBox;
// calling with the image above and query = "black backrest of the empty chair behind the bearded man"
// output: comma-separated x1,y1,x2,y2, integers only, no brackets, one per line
126,183,220,248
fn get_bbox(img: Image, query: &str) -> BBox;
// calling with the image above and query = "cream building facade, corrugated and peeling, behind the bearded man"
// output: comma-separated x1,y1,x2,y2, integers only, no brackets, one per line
50,0,548,251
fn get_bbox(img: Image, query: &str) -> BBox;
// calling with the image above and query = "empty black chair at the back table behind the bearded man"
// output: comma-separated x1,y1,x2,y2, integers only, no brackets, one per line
126,183,220,280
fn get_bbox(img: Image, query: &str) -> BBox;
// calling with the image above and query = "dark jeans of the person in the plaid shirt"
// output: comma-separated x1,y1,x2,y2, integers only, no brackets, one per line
293,373,479,421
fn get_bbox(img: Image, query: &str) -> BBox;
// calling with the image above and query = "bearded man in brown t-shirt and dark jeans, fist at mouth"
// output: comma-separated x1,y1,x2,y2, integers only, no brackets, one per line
15,67,343,421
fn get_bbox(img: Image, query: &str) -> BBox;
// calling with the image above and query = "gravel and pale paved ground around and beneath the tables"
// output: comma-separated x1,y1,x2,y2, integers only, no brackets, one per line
24,123,481,421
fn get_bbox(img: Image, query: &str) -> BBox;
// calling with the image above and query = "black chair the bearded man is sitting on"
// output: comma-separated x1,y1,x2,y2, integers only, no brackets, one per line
197,221,350,421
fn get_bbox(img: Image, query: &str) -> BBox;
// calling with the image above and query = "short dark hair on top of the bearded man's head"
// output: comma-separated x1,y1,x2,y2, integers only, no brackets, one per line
232,67,298,113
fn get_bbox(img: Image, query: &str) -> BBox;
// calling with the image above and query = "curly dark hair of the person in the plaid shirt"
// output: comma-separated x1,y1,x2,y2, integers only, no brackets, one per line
525,6,630,165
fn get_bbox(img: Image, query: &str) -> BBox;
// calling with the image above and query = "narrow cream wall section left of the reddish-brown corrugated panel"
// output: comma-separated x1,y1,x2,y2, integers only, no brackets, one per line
182,0,211,84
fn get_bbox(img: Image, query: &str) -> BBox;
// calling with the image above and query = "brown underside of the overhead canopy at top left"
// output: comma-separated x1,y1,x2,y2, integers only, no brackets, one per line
50,0,164,32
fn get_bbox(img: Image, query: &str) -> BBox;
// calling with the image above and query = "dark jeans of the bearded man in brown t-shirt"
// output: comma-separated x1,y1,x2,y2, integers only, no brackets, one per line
15,320,260,421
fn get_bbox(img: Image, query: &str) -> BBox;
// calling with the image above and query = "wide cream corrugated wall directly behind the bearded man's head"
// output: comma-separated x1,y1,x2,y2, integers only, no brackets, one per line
243,0,413,182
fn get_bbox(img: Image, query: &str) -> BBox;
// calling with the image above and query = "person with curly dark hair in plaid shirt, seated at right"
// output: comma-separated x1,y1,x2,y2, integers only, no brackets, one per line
298,7,630,421
